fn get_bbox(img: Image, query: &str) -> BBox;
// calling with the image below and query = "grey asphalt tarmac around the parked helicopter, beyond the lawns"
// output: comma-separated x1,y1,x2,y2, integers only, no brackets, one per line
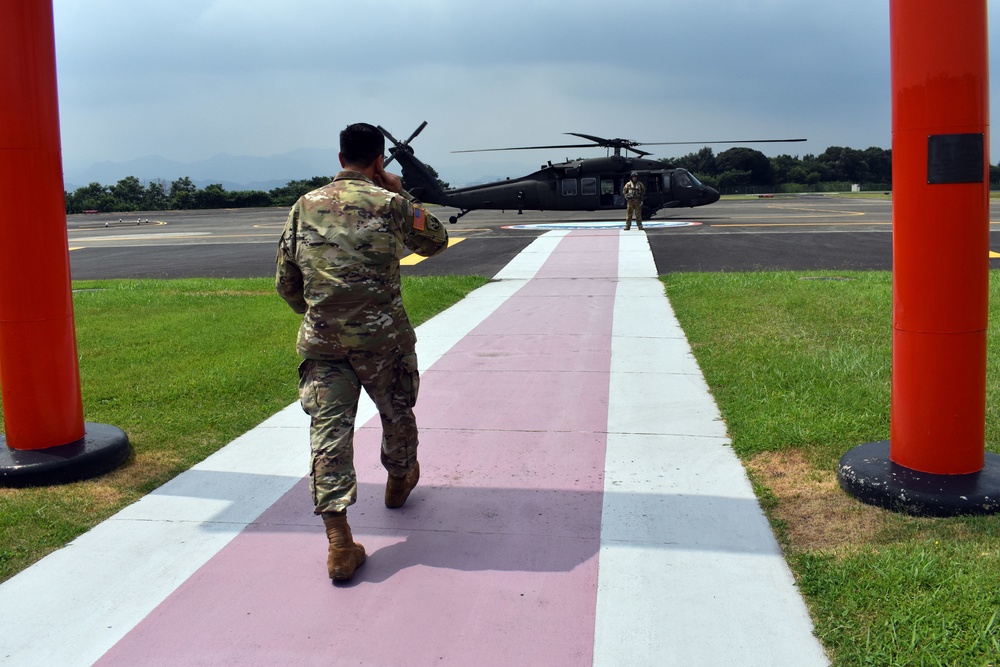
67,195,1000,280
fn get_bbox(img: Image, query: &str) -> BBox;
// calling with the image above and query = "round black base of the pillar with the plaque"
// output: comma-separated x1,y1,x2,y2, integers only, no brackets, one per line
837,440,1000,516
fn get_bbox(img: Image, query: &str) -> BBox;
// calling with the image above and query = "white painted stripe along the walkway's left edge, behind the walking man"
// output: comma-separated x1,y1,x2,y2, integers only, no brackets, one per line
0,232,564,667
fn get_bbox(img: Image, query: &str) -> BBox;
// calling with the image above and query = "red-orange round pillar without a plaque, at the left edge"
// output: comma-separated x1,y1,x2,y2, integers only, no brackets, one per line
0,0,85,450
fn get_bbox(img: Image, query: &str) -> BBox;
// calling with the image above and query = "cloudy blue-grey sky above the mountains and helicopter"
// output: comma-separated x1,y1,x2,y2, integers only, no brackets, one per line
54,0,1000,175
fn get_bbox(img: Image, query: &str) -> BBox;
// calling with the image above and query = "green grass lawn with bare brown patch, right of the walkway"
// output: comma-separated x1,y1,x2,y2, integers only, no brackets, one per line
663,272,1000,666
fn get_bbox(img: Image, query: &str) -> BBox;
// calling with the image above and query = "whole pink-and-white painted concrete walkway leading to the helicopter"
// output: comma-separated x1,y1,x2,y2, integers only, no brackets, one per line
0,231,828,667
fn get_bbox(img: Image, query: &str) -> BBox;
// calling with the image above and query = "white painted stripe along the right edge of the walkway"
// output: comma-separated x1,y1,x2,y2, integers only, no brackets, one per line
593,234,828,667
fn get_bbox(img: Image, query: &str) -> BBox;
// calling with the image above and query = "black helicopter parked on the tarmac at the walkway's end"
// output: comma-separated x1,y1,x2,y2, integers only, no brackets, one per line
378,121,805,224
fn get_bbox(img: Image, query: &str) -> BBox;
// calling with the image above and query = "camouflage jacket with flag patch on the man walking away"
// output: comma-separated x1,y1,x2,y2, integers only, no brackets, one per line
275,171,448,359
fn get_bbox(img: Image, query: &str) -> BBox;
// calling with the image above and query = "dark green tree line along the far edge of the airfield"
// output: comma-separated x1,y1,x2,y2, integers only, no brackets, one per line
66,146,1000,213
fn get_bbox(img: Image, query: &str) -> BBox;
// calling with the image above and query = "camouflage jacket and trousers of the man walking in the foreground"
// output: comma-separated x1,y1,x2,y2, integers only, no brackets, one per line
275,171,448,514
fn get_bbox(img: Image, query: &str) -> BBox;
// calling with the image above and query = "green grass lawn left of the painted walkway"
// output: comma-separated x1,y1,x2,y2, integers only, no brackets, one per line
0,277,486,581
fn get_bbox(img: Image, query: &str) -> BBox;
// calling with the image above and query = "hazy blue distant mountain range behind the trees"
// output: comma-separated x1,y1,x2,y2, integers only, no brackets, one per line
63,148,532,192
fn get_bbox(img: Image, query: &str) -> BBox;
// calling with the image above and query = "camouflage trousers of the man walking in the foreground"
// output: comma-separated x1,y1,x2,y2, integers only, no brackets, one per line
299,351,420,514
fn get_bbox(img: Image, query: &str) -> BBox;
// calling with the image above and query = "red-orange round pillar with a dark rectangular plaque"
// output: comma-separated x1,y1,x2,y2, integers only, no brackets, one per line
890,0,989,474
